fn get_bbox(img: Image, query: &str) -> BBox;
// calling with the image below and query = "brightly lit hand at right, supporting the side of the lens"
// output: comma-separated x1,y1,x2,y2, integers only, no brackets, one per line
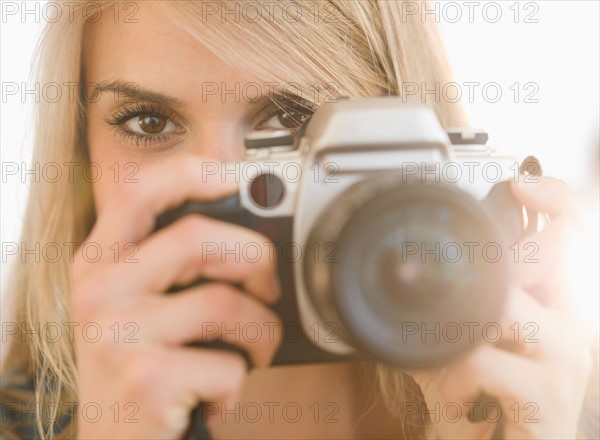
411,178,593,439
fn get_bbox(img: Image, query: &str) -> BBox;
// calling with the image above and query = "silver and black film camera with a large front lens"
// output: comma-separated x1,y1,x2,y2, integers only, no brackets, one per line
157,97,539,368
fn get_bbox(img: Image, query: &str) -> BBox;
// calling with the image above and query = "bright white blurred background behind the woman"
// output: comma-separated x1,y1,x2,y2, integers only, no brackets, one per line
1,1,600,325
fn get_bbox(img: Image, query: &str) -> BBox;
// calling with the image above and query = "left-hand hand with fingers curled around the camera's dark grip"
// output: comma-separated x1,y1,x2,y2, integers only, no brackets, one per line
71,158,280,439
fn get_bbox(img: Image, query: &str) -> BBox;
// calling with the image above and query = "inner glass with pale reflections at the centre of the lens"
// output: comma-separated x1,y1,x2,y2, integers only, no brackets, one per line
370,200,481,313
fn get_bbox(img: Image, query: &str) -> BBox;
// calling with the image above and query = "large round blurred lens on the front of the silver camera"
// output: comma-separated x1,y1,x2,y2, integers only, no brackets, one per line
304,177,508,367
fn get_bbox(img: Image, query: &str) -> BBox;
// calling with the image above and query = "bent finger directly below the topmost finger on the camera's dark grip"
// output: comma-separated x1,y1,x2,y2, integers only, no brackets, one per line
130,214,280,302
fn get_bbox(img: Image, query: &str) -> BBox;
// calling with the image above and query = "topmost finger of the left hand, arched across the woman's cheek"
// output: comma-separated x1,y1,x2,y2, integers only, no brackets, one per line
90,157,238,246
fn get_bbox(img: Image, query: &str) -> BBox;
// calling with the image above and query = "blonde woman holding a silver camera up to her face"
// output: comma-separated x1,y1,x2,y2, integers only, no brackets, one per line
2,0,591,439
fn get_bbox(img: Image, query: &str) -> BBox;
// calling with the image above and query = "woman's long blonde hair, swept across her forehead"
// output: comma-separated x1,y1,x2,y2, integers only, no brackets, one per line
5,0,465,438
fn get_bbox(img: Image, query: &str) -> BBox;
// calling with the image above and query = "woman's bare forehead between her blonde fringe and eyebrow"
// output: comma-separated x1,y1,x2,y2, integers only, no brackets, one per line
84,2,252,96
